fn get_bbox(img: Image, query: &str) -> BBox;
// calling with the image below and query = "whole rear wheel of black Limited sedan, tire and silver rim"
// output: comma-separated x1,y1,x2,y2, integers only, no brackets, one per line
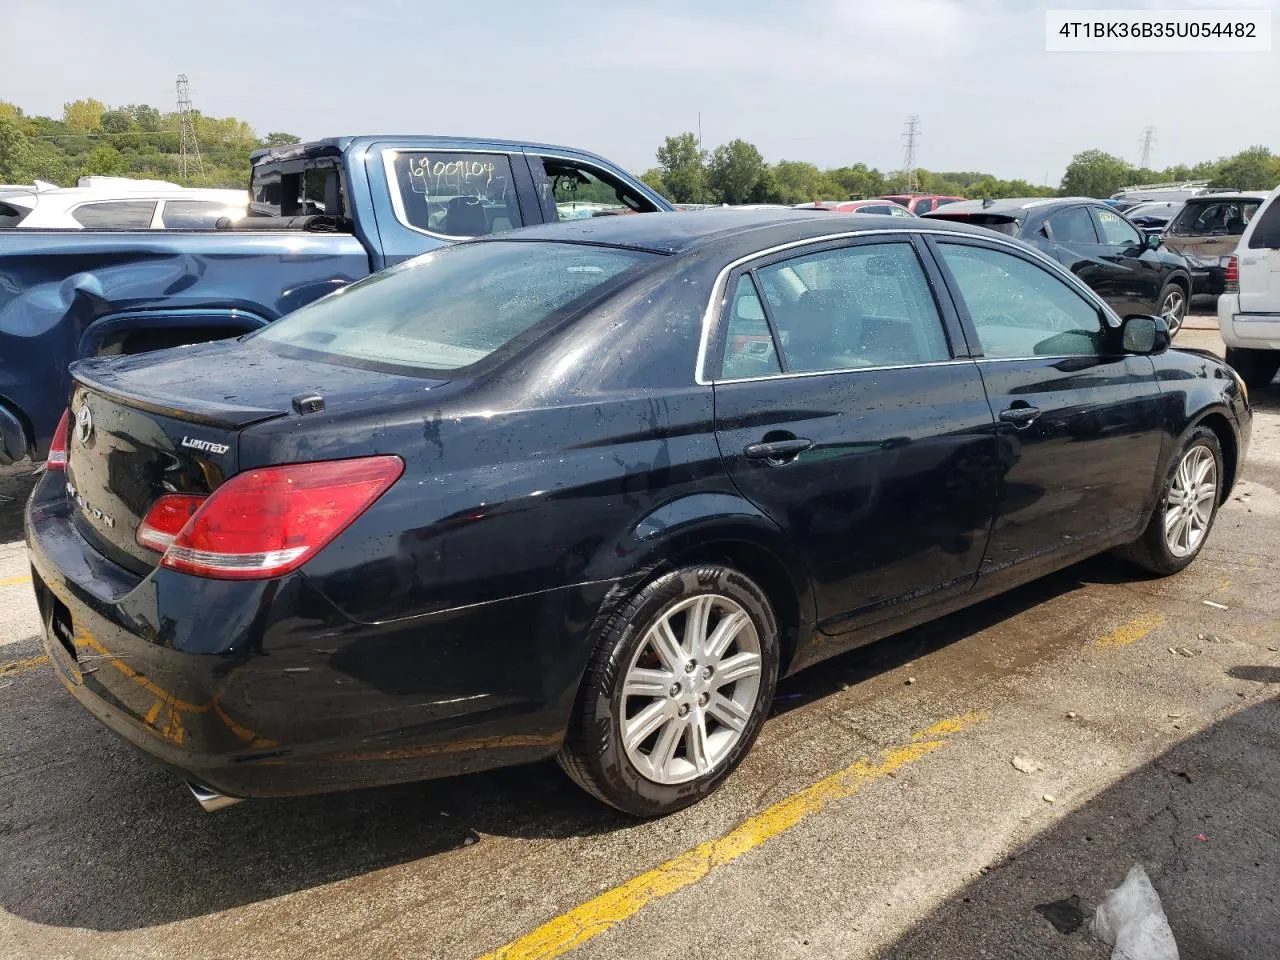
559,564,780,817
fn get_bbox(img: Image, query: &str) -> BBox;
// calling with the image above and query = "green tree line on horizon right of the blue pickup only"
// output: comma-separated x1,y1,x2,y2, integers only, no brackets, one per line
643,133,1280,204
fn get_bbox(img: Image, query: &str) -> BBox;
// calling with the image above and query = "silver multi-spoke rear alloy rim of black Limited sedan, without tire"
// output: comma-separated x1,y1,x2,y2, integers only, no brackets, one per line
621,594,763,783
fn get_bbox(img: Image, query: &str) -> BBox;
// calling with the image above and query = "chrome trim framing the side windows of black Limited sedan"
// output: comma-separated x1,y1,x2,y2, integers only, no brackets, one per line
694,229,1120,387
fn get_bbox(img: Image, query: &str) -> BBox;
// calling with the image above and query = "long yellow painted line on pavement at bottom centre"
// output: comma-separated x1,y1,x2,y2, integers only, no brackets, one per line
481,713,984,960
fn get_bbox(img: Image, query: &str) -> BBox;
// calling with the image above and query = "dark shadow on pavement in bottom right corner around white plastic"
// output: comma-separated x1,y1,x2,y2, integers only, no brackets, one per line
877,696,1280,960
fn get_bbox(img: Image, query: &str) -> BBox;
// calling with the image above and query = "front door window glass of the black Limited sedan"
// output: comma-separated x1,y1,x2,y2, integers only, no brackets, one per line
938,242,1106,358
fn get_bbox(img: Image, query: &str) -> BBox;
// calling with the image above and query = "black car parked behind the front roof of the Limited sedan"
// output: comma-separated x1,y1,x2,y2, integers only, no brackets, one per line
927,197,1192,337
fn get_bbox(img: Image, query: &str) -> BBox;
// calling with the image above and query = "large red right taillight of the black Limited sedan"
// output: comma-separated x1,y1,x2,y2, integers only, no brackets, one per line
155,456,404,580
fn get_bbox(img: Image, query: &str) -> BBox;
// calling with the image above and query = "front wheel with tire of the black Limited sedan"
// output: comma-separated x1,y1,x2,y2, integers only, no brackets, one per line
1117,426,1225,576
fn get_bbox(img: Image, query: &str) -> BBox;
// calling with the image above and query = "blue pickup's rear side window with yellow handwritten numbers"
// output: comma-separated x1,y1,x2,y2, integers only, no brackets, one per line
388,150,524,237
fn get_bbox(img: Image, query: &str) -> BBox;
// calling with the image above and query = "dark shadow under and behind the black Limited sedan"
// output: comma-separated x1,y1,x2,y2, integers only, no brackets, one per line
0,557,1182,931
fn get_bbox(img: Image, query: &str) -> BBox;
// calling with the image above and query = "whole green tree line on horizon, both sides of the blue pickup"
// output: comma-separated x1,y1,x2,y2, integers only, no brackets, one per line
0,99,1280,204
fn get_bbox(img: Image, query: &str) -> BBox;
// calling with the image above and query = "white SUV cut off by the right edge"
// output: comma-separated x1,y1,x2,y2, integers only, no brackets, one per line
1217,187,1280,387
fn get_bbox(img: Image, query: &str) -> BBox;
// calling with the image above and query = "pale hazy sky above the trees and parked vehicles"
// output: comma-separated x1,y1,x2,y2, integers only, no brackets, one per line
0,0,1280,186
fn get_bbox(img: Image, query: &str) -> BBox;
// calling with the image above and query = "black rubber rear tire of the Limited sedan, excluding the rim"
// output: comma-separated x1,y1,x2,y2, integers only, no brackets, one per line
559,564,780,817
